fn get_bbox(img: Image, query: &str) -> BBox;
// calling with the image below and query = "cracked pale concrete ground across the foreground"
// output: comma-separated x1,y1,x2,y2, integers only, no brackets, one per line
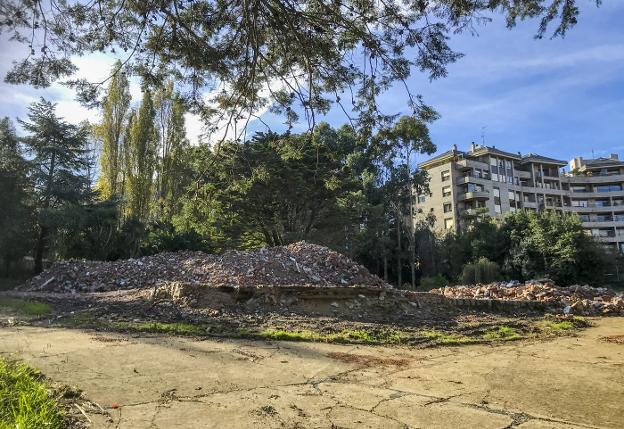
0,318,624,429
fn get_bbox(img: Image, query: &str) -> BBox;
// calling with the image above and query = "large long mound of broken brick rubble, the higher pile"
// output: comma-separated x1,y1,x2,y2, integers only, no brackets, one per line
22,242,391,293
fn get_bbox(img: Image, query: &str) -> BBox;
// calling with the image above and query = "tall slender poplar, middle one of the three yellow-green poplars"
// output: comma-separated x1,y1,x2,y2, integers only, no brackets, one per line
125,89,158,223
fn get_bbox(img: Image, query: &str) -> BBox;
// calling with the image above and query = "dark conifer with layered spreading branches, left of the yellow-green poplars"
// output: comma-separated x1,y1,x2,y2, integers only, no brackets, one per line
19,98,90,272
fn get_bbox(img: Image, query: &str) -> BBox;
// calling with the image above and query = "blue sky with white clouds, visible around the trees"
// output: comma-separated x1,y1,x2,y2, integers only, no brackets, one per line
0,0,624,166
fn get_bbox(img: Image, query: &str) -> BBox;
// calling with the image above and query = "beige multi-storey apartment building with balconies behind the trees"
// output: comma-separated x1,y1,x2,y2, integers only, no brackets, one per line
416,143,624,252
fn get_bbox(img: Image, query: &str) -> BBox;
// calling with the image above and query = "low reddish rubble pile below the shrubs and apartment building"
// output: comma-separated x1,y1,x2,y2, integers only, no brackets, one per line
431,280,624,316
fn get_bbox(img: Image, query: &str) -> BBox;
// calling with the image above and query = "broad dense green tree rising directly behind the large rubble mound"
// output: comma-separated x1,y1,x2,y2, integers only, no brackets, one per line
176,124,364,252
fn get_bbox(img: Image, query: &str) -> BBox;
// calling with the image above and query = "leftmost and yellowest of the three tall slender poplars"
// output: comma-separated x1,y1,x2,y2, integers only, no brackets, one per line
95,61,130,199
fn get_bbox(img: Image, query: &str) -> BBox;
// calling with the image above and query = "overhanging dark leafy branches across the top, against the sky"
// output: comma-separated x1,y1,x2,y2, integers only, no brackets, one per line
0,0,600,133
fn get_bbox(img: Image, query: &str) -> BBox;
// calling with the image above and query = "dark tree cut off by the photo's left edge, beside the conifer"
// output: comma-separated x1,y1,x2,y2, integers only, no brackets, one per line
0,118,33,277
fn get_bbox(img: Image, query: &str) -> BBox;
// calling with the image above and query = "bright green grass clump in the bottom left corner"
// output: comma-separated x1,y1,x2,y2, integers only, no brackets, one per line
0,358,65,429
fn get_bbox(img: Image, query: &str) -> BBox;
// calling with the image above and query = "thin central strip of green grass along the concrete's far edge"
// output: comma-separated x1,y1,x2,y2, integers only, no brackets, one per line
252,329,405,344
